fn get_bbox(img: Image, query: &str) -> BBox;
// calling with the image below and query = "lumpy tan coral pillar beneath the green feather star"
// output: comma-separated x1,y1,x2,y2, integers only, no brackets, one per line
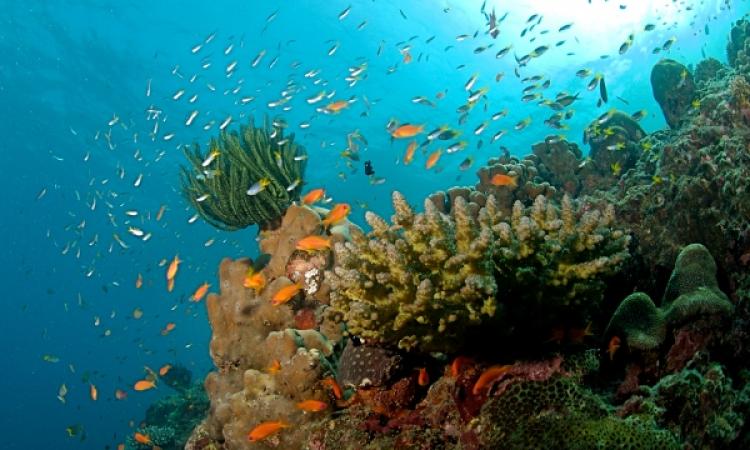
191,206,346,449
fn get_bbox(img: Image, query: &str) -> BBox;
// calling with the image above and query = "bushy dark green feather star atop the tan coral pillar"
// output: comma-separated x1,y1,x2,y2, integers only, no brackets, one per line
181,121,306,231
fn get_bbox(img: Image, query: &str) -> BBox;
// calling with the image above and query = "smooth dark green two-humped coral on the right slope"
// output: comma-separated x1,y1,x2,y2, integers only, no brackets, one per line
605,244,734,350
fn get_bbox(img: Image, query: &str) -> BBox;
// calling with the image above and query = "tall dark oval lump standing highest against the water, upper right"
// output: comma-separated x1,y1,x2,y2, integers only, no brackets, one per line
651,59,695,128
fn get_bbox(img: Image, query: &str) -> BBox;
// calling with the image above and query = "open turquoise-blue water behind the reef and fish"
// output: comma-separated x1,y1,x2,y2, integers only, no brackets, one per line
0,0,750,450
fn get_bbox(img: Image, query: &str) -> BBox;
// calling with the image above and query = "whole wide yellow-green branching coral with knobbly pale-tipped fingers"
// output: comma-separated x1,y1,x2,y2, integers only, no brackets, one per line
326,192,629,353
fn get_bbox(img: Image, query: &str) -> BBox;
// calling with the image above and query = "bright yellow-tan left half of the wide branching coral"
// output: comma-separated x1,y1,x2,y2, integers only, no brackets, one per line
326,192,499,352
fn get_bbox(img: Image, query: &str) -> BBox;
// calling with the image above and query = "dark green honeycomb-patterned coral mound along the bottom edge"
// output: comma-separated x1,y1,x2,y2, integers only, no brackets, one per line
479,376,680,449
